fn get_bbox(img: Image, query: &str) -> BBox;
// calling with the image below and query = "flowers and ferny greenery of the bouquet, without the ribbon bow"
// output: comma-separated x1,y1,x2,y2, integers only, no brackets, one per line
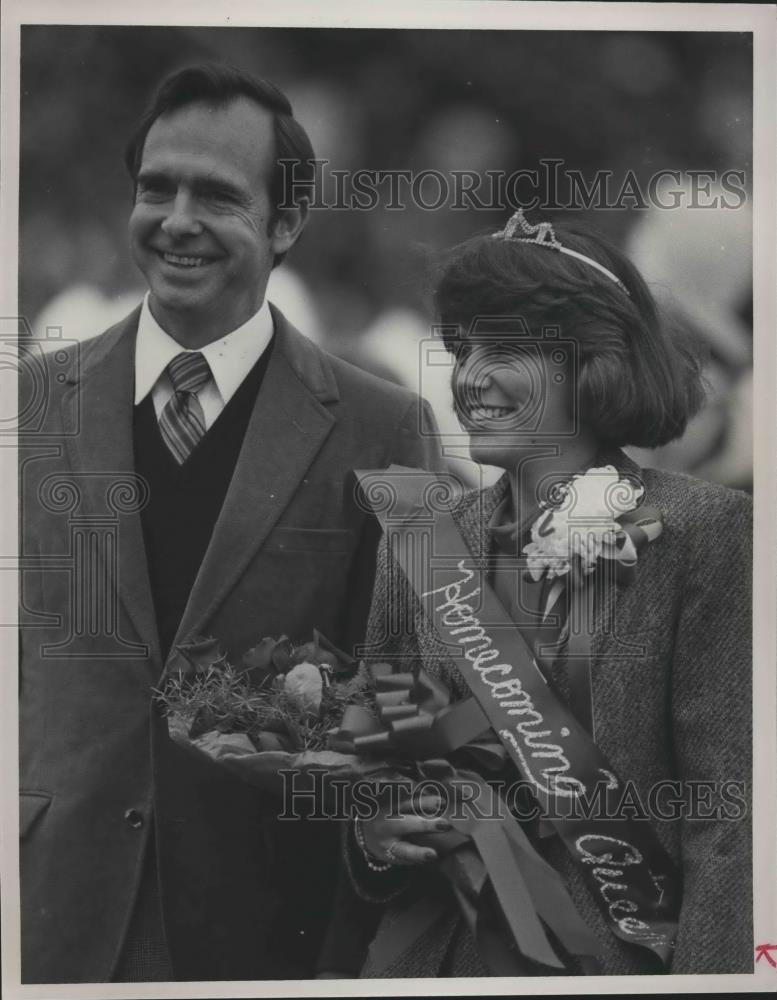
155,631,386,794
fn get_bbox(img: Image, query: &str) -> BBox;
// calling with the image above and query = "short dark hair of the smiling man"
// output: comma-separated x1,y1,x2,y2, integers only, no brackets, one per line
124,63,315,266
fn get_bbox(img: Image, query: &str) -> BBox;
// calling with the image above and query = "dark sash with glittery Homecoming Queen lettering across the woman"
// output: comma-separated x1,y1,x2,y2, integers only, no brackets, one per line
355,466,679,967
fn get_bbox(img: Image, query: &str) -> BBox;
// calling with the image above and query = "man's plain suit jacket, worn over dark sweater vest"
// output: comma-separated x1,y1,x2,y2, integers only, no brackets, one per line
20,300,440,983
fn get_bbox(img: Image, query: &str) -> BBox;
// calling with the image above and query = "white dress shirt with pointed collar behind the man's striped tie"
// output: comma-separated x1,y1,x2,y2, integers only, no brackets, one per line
135,295,273,430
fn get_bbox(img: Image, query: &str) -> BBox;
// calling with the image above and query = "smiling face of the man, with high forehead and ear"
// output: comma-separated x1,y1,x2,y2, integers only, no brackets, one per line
129,97,301,346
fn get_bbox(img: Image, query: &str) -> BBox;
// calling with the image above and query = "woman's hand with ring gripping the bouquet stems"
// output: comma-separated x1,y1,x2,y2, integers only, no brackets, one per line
361,796,453,865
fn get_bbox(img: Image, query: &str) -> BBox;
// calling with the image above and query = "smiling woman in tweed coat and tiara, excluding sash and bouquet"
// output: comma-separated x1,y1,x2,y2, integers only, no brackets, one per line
347,212,753,976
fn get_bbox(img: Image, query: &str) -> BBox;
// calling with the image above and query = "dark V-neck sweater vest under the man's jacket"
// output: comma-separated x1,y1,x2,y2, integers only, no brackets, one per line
134,339,274,658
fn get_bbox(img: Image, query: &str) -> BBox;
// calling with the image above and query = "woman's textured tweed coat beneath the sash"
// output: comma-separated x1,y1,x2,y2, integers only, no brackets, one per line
361,451,753,977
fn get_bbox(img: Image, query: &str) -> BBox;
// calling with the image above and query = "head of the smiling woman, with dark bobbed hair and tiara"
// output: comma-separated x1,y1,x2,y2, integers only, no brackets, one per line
435,211,704,512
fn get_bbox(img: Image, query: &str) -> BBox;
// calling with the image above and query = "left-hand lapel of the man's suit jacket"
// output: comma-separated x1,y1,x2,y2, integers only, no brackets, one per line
62,308,161,663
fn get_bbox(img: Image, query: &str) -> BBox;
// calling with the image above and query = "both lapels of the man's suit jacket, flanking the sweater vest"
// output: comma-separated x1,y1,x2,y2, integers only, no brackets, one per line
61,307,339,672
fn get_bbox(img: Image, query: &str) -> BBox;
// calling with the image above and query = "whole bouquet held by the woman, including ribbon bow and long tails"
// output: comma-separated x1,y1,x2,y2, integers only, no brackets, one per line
157,632,594,975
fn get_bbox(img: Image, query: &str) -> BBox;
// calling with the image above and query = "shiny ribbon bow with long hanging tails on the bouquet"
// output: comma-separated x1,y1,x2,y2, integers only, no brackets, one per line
330,663,598,975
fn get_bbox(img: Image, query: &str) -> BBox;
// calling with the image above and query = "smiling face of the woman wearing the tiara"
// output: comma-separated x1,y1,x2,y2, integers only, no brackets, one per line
452,338,577,469
